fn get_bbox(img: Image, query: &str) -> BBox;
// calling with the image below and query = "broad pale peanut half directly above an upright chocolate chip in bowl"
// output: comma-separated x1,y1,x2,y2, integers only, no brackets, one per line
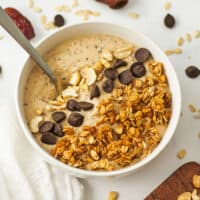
81,67,97,85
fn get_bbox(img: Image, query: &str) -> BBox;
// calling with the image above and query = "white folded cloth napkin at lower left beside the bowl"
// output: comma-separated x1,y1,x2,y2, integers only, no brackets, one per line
0,103,83,200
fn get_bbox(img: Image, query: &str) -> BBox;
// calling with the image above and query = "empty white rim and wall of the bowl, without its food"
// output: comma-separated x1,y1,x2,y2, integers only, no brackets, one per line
16,22,181,178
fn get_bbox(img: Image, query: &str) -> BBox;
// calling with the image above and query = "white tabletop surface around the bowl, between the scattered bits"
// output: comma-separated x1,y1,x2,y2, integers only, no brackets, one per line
0,0,200,200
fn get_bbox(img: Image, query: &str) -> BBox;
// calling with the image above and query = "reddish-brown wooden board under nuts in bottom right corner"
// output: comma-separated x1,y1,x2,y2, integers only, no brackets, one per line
145,162,200,200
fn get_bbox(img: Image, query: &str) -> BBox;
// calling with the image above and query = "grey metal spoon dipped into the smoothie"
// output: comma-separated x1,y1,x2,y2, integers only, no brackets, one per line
0,6,61,96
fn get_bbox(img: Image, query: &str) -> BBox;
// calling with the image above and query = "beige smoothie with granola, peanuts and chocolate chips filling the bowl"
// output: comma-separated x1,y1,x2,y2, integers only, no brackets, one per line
25,35,172,171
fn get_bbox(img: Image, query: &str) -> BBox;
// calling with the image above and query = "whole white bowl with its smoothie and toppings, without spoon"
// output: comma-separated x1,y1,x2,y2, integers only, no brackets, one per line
16,22,181,177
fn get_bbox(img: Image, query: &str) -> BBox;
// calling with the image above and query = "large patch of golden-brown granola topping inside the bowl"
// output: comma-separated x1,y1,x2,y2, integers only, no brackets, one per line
51,61,171,171
